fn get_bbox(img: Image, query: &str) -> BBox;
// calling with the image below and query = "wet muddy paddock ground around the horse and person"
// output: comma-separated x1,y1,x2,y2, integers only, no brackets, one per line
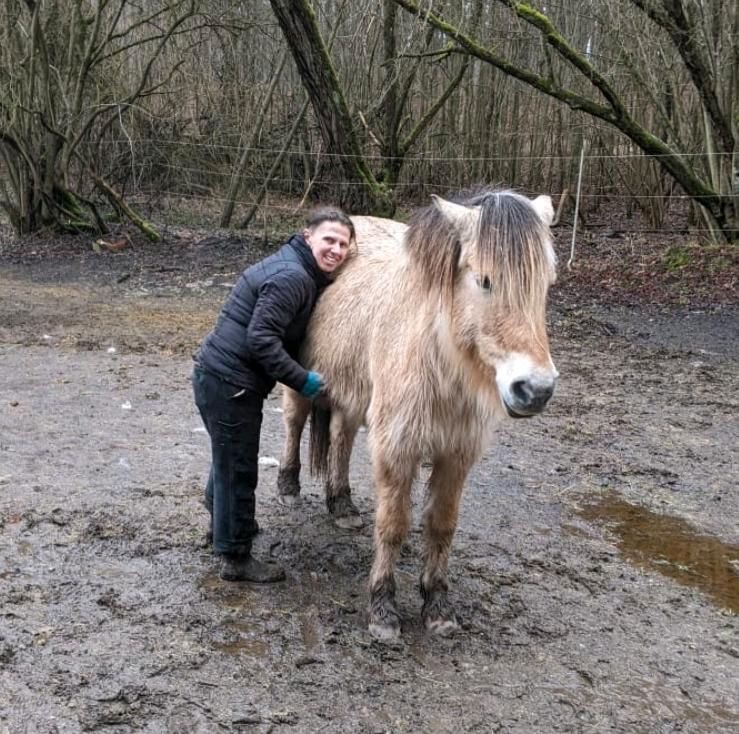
0,226,739,734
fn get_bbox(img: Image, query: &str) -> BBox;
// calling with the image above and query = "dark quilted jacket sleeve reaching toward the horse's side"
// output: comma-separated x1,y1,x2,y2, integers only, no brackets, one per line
247,270,313,392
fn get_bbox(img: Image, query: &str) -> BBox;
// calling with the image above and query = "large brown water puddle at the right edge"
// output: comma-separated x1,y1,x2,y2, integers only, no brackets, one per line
578,492,739,614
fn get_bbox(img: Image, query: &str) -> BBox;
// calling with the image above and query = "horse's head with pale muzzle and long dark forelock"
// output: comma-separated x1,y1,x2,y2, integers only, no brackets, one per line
434,191,558,418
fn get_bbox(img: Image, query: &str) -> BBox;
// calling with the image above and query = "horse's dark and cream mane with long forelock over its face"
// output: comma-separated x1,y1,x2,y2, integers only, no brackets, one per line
406,189,553,313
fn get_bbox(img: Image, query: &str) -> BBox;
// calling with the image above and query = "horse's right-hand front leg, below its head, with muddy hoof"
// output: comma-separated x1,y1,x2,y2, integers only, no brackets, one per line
421,454,473,635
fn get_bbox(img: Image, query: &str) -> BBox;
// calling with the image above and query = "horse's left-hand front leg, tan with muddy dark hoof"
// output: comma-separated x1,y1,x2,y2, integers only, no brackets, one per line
369,458,416,640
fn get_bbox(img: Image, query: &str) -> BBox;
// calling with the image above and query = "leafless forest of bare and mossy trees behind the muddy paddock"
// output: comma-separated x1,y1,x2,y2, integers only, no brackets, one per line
0,0,739,243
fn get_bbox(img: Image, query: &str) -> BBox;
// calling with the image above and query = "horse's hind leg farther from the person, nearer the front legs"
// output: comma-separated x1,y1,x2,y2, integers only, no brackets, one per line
326,410,364,529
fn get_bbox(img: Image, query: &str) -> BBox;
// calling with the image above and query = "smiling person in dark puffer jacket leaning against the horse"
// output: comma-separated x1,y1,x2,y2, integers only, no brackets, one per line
193,209,355,583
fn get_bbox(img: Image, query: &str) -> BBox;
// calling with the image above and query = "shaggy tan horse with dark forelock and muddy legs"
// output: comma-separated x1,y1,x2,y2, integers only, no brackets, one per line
278,190,558,640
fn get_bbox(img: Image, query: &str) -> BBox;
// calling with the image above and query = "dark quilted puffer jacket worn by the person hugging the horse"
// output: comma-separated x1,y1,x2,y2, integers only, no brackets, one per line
195,235,331,396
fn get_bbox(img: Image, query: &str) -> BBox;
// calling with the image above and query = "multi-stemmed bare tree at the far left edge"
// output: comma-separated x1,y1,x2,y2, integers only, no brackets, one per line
0,0,196,239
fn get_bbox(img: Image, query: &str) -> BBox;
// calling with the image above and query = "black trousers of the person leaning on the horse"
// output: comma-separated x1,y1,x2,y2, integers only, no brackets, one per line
192,366,264,555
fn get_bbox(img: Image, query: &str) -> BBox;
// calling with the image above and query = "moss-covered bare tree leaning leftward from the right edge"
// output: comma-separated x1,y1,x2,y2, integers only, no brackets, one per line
393,0,739,239
